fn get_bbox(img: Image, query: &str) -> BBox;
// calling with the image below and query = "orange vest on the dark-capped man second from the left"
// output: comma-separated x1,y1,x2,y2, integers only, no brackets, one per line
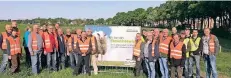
8,37,21,55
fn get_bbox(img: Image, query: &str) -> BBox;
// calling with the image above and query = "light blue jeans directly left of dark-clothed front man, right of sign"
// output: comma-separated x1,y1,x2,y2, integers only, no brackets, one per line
159,57,169,78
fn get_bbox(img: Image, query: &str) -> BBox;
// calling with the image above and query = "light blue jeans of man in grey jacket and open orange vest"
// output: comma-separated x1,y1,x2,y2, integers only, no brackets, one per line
31,52,41,74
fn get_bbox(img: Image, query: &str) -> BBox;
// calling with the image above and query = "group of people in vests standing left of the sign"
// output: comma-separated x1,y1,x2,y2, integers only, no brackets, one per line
0,21,105,75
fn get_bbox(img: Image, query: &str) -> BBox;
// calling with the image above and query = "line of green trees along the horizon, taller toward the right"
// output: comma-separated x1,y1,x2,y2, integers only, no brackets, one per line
0,1,231,30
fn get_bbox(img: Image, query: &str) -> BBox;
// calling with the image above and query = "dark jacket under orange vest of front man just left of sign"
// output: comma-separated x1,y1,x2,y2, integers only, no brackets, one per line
73,39,92,55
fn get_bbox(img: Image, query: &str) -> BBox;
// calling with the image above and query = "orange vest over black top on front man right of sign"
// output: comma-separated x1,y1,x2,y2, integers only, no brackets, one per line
170,41,184,59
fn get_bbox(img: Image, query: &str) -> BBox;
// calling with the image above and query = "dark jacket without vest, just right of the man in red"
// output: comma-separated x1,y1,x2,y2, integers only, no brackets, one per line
57,35,66,53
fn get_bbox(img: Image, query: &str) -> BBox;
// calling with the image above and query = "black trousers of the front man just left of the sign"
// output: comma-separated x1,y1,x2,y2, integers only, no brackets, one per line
73,54,91,74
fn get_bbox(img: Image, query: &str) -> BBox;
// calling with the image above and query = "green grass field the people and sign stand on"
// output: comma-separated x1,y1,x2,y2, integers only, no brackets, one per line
0,23,231,78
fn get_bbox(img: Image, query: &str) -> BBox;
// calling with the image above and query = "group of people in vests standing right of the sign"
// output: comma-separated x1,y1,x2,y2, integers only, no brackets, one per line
133,27,220,78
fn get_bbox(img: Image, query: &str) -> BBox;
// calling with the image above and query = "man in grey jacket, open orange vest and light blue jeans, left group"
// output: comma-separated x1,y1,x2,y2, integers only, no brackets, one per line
27,24,43,74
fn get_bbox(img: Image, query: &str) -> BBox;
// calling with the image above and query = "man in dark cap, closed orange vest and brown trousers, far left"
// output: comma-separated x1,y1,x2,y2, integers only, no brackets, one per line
6,29,21,73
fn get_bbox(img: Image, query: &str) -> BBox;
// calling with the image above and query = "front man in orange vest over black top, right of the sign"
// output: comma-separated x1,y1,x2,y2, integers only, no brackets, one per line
170,34,186,78
